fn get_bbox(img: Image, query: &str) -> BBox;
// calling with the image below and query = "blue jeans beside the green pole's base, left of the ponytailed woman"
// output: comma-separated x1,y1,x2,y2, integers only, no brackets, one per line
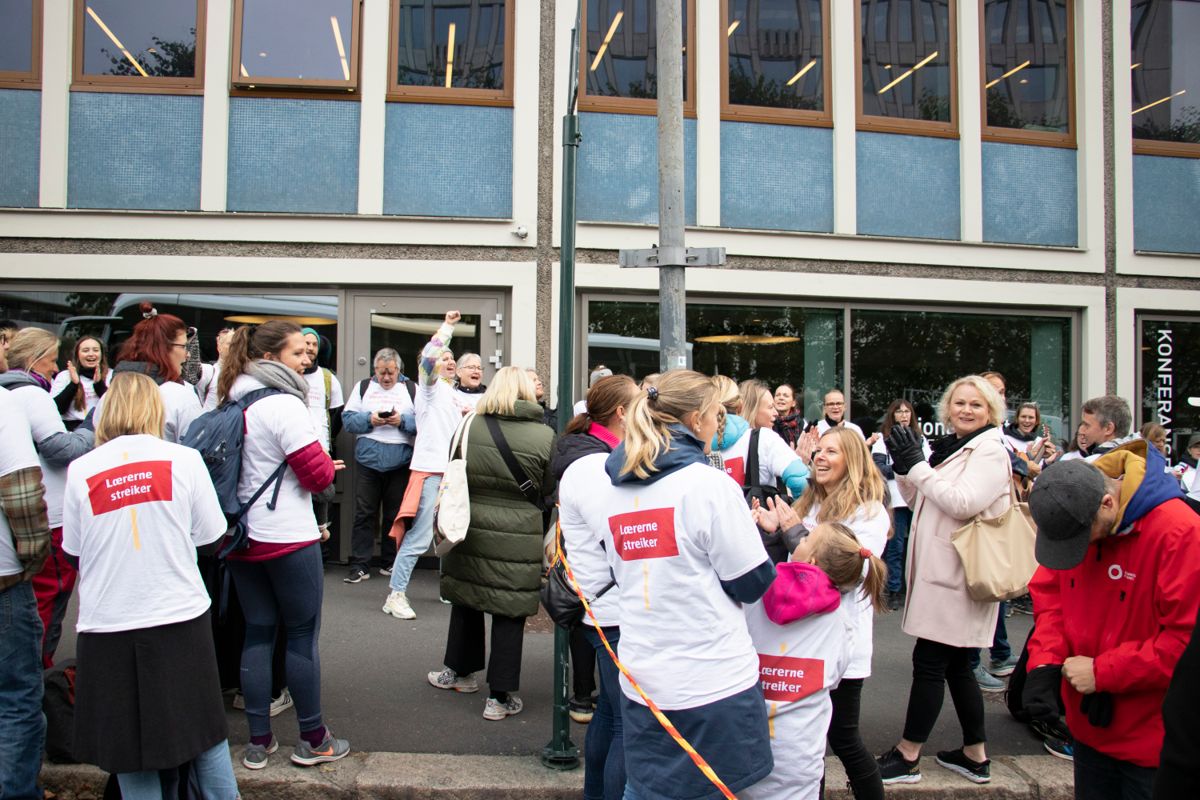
583,621,625,800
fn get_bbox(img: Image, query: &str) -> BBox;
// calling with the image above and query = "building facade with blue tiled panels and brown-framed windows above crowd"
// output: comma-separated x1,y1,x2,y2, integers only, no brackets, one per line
0,0,1200,462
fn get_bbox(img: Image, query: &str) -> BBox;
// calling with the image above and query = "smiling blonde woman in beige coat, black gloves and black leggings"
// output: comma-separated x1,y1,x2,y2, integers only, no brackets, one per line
880,375,1012,783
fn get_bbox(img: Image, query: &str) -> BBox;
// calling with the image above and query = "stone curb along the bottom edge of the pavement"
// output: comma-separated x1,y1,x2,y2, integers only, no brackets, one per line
42,747,1075,800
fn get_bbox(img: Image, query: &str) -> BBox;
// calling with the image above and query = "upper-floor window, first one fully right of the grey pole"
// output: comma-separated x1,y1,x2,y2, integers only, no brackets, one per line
722,0,829,122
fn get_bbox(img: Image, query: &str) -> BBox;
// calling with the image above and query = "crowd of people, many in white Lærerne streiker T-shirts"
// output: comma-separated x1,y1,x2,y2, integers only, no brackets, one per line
0,305,1200,800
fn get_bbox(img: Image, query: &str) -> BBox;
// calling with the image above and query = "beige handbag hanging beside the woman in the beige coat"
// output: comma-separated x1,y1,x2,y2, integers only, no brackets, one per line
950,480,1038,603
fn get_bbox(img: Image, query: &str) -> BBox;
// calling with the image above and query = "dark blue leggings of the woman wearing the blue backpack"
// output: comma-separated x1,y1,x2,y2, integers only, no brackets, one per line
229,542,325,736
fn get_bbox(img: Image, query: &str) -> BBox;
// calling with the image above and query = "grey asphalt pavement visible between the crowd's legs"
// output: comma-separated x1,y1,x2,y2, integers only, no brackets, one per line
58,565,1044,756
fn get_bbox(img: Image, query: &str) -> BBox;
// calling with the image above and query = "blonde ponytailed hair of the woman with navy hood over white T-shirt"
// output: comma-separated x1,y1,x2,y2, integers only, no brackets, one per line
620,369,715,479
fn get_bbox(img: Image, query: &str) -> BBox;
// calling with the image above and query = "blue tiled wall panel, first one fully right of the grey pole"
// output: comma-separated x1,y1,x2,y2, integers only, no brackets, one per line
721,122,833,233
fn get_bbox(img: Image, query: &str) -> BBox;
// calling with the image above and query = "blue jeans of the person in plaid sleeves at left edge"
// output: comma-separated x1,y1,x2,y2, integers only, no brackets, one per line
0,581,46,800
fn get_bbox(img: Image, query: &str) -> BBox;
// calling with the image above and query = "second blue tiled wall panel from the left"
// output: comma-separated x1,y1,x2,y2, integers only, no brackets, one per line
67,91,204,211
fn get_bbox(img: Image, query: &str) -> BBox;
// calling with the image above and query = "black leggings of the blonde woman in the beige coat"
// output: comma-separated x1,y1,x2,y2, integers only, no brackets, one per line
904,639,988,747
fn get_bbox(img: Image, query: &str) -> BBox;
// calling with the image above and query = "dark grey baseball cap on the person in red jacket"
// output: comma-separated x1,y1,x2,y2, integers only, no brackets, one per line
1030,459,1104,570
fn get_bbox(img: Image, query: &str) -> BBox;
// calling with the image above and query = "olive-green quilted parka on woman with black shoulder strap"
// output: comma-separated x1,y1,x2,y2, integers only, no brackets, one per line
442,401,554,616
